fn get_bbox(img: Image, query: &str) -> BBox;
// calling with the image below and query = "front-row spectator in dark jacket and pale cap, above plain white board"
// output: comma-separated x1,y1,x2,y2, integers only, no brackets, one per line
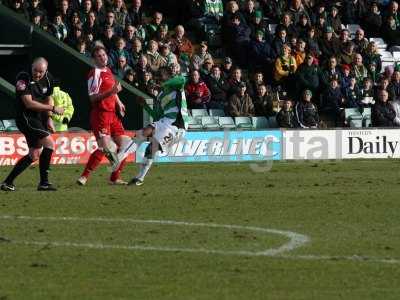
295,90,319,128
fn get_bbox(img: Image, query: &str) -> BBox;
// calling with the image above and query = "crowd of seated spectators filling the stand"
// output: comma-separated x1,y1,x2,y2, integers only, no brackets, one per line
4,0,400,128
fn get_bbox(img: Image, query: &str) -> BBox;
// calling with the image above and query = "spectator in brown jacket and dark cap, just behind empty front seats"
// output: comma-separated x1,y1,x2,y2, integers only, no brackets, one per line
228,82,254,117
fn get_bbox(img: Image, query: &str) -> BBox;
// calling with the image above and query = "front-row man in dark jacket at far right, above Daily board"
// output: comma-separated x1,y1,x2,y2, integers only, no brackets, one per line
372,90,396,127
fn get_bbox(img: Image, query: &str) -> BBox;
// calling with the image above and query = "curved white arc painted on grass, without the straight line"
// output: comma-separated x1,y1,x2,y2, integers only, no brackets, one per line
0,216,310,256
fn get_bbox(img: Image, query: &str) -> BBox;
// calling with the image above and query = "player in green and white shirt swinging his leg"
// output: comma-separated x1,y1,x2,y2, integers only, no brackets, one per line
113,64,189,185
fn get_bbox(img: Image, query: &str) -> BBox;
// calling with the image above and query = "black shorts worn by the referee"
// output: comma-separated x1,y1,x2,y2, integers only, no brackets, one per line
16,114,50,148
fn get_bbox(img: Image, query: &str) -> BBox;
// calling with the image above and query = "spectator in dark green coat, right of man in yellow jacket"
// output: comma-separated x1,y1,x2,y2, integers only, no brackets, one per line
296,53,320,94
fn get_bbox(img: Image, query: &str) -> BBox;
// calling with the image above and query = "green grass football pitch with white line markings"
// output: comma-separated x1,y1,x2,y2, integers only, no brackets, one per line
0,160,400,300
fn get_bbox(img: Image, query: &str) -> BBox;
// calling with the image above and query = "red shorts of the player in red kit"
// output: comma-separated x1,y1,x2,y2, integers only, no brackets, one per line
90,111,125,139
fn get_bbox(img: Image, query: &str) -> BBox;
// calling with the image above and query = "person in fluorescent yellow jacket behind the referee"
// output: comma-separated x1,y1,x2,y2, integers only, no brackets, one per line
51,80,74,132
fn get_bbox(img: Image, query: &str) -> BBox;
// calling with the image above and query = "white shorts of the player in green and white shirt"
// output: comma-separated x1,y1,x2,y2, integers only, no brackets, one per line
150,118,185,152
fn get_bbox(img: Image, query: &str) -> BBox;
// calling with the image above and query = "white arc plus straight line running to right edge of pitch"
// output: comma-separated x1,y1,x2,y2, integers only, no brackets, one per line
0,215,400,265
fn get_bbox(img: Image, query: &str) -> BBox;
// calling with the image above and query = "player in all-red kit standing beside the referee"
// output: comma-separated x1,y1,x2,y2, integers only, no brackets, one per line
77,46,130,185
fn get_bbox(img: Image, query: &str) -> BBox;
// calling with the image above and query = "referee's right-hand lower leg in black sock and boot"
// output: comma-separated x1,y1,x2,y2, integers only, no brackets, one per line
37,136,57,191
